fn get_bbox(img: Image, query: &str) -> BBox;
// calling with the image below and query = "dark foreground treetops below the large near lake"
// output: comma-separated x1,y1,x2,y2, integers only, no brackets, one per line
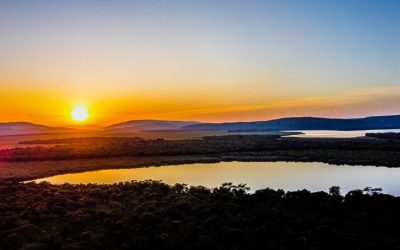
0,181,400,250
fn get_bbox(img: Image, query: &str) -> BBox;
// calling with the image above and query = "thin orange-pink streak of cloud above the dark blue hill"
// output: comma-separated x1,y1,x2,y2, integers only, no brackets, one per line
148,87,400,120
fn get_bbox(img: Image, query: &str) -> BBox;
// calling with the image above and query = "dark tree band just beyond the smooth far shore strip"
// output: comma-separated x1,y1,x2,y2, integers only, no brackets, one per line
0,135,400,166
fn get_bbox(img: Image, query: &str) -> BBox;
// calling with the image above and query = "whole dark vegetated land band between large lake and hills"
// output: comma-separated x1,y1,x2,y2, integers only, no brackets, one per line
0,135,400,181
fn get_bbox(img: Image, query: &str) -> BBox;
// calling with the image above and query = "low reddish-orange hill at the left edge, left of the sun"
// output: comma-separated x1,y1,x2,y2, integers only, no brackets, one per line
0,122,73,136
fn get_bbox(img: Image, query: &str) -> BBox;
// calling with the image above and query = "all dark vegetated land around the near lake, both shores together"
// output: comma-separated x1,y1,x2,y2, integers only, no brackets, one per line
0,135,400,250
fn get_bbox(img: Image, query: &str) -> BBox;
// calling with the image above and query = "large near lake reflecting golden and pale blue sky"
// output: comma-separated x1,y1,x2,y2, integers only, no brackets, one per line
32,162,400,196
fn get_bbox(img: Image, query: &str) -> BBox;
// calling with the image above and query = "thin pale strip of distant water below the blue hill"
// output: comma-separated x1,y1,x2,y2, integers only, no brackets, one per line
287,129,400,138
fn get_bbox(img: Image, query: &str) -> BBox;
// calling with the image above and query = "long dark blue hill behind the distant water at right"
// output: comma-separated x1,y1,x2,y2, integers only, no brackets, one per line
181,115,400,131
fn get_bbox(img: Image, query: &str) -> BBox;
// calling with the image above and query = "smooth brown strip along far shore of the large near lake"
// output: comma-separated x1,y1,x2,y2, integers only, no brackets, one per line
0,148,398,181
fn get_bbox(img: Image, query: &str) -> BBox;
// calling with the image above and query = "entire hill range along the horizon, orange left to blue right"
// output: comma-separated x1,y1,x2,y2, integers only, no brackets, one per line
0,115,400,136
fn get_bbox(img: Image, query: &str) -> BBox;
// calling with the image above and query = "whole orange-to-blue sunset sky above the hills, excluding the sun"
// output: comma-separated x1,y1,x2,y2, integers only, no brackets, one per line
0,0,400,125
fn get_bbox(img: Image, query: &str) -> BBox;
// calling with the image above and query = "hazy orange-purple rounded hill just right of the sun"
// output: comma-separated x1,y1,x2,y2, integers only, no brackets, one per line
105,120,200,132
